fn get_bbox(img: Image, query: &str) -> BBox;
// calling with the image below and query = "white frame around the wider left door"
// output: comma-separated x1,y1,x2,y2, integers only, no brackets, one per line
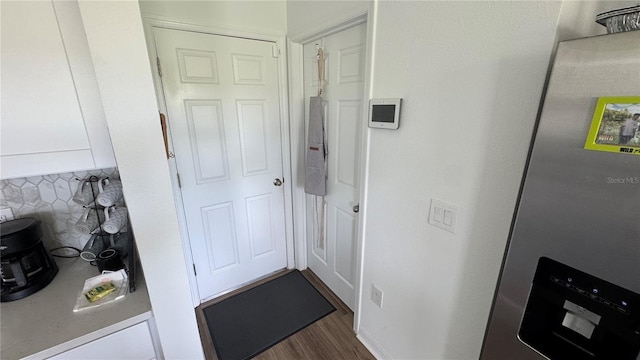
142,16,295,308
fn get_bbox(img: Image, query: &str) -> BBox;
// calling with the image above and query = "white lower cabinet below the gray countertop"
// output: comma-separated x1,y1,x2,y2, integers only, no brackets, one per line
49,321,156,360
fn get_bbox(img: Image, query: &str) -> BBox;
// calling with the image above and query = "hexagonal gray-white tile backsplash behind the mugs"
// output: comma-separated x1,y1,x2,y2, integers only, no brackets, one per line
0,168,120,249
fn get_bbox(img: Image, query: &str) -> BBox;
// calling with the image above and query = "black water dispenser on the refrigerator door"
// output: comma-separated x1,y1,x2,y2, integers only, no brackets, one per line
518,257,640,360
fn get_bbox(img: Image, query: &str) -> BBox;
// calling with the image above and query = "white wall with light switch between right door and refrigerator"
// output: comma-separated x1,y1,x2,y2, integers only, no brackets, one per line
287,1,633,359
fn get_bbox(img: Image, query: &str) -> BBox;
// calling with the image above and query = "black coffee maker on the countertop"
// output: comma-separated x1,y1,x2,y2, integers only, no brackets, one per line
0,218,58,302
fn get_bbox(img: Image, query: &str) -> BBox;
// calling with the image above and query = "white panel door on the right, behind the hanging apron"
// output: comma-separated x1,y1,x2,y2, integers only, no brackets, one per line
304,24,366,309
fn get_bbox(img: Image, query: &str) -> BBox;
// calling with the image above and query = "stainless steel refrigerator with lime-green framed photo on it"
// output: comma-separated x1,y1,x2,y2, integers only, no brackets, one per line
481,31,640,360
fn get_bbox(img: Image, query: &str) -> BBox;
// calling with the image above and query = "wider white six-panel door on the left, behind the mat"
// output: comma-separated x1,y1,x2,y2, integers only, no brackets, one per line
154,28,287,300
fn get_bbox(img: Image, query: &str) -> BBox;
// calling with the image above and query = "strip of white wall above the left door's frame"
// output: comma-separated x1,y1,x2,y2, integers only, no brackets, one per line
140,0,287,35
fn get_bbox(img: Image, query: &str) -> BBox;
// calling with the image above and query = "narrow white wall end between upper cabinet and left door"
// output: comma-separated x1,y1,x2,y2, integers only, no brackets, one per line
80,1,204,359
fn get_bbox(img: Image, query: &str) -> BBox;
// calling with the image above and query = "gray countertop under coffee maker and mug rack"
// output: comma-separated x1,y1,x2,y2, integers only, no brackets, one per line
0,258,152,360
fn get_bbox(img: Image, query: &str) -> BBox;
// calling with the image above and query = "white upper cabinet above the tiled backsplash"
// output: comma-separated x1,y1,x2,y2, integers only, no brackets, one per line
0,1,115,179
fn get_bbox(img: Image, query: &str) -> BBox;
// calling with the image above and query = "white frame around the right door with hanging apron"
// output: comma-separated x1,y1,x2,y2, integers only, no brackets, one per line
287,1,376,334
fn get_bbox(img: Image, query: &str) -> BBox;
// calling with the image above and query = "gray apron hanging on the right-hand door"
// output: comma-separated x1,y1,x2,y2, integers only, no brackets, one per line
304,96,327,196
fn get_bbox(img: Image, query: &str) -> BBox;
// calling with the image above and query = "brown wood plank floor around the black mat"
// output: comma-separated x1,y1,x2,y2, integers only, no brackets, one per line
196,270,375,360
